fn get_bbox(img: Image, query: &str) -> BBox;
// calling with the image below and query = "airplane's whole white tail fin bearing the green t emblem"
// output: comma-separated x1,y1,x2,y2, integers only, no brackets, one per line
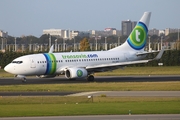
109,12,151,51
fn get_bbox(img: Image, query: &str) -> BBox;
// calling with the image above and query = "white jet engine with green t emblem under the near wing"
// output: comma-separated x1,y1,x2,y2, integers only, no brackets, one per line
65,68,88,79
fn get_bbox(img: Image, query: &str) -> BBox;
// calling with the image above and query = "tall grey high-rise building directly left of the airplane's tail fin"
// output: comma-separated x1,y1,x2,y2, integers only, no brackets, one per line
121,20,137,36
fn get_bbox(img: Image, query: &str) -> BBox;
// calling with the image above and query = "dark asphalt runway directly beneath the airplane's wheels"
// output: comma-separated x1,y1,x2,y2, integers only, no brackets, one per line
0,75,180,85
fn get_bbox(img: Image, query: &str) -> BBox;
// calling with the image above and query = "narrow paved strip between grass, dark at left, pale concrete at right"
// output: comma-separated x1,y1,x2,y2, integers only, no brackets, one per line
0,91,180,97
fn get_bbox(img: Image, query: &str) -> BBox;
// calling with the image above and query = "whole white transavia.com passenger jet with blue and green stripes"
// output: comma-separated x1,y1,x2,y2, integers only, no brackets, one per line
4,12,164,81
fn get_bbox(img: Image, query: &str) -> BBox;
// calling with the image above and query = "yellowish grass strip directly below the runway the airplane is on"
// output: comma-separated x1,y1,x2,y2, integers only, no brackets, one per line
0,81,180,92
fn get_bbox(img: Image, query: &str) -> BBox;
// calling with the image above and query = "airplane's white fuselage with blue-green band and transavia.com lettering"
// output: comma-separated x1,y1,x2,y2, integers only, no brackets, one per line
5,51,145,76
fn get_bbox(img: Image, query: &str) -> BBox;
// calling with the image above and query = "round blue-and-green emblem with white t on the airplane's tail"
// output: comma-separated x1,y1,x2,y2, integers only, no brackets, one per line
127,22,148,50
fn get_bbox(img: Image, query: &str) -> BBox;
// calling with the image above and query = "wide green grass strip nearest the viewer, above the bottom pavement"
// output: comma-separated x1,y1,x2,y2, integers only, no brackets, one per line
0,97,180,117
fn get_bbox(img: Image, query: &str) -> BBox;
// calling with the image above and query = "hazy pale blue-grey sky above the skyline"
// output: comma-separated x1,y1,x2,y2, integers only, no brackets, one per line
0,0,180,37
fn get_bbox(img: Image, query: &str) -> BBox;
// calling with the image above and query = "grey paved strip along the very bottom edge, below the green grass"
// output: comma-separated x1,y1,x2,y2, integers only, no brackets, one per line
0,114,180,120
